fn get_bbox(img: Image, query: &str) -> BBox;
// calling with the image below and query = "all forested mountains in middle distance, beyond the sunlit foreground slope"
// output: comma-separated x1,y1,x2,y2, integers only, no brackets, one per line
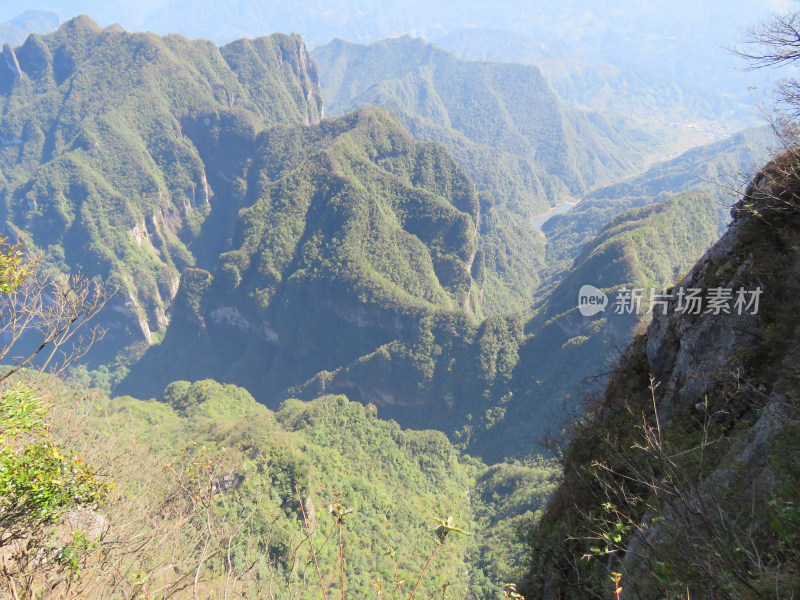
0,17,762,458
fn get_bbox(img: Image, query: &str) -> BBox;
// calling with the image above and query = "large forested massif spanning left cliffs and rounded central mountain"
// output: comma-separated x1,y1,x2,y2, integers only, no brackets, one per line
0,17,544,410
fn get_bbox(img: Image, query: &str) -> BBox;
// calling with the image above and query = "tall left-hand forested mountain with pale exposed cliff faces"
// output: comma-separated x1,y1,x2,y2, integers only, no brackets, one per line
0,16,323,343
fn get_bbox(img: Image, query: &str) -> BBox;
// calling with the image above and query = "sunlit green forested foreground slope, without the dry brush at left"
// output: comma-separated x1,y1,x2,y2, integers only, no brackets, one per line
75,380,555,598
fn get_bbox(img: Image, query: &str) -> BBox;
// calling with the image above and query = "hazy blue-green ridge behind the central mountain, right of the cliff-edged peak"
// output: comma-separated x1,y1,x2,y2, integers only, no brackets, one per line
312,36,646,216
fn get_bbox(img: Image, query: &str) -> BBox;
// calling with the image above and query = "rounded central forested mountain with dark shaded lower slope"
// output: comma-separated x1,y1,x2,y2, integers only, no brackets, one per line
119,109,490,400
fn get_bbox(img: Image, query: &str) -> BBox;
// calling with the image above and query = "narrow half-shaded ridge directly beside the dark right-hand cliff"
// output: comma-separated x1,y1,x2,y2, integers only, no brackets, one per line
473,192,716,462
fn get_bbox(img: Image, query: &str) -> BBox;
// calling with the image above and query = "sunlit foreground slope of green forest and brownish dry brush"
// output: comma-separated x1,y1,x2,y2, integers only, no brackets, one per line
36,380,556,598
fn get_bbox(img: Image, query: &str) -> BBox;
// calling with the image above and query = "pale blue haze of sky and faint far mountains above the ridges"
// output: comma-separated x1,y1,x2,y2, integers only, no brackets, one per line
0,0,772,137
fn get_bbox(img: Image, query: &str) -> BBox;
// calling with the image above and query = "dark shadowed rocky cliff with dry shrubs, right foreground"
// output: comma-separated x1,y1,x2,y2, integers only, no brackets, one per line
526,152,800,598
